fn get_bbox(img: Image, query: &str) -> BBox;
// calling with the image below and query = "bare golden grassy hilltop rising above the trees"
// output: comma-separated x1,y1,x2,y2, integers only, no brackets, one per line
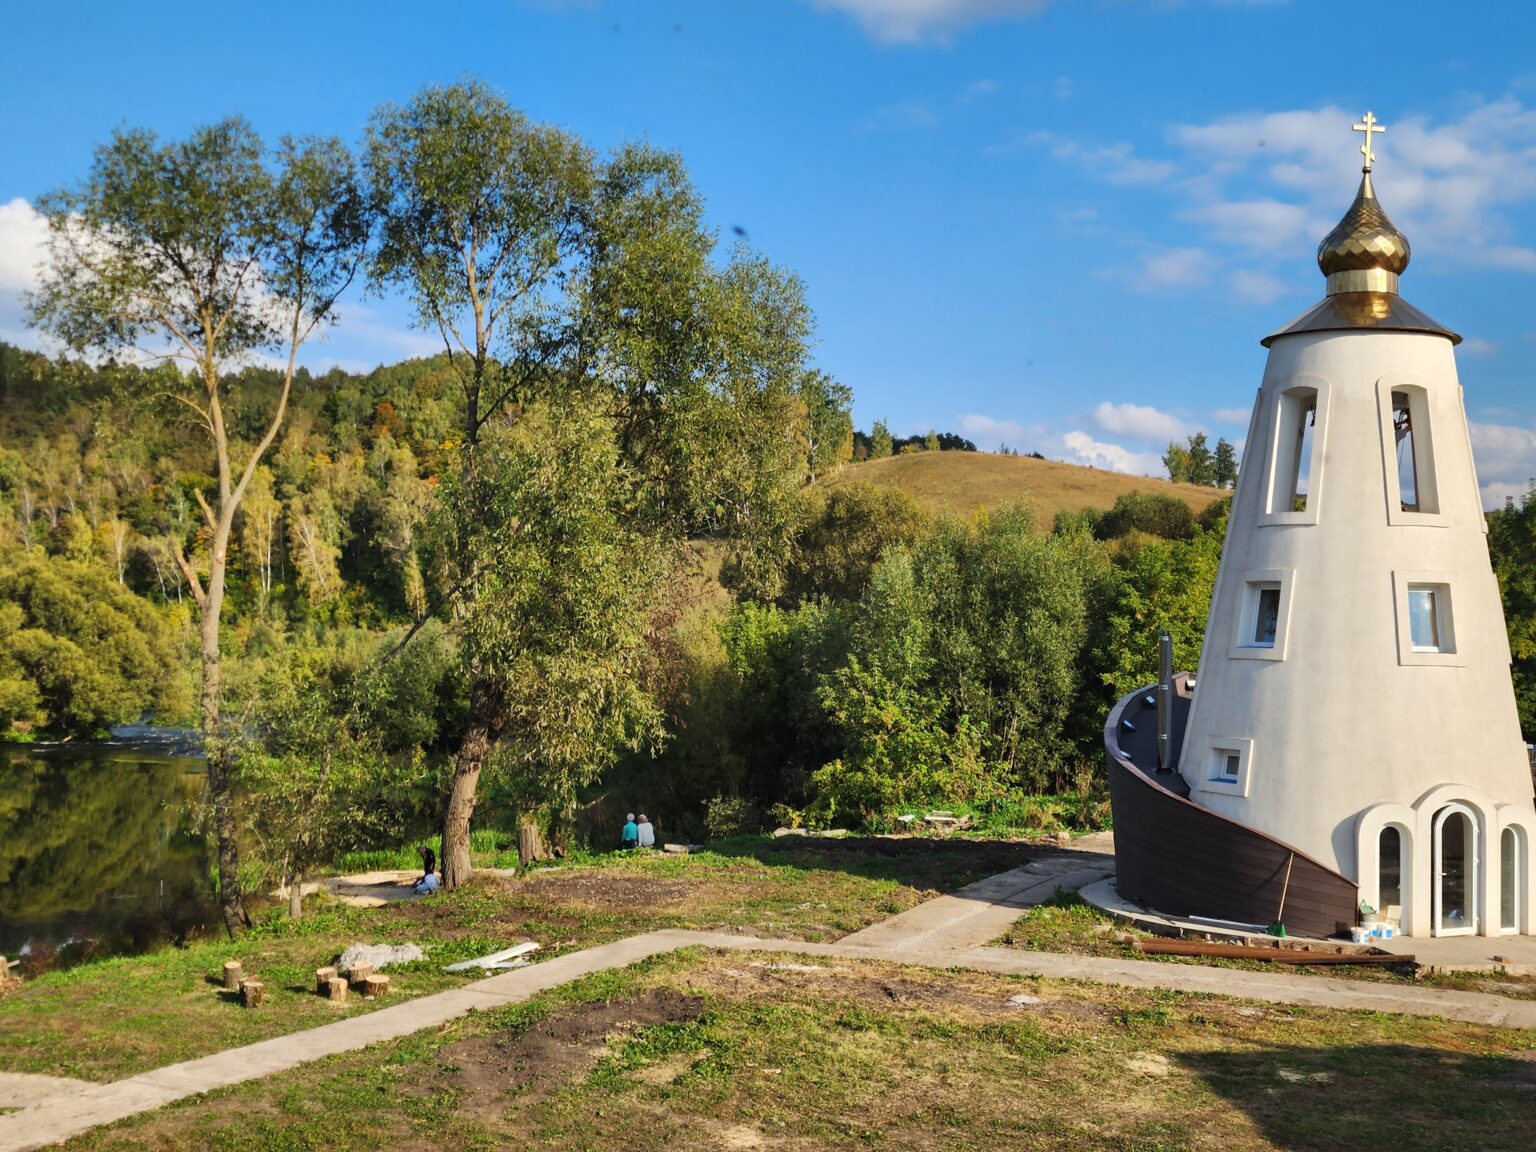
819,452,1223,528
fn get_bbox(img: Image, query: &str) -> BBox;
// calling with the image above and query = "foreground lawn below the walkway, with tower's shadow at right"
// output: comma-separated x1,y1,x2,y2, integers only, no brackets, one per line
54,952,1536,1152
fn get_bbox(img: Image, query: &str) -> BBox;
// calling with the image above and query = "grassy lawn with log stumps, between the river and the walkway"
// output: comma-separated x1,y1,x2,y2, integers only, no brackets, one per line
0,837,1038,1081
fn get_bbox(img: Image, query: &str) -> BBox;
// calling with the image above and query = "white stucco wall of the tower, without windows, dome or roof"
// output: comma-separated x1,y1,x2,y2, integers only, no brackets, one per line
1180,330,1536,931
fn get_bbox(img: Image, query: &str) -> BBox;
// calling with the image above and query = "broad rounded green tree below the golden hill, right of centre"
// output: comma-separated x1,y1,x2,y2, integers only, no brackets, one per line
813,505,1109,823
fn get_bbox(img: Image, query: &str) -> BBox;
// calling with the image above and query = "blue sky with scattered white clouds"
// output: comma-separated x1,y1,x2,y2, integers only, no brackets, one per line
0,0,1536,504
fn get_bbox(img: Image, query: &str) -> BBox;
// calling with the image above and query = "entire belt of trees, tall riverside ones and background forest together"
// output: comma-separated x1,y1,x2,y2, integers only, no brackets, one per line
12,81,1536,932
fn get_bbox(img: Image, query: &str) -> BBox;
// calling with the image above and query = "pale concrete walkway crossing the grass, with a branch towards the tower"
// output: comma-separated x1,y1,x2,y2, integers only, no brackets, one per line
0,852,1536,1152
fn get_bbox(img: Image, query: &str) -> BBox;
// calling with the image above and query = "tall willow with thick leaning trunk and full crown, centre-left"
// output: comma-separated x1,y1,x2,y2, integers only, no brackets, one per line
369,81,811,888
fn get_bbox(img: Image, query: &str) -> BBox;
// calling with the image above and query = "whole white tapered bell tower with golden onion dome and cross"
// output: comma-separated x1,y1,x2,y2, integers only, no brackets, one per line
1178,112,1536,935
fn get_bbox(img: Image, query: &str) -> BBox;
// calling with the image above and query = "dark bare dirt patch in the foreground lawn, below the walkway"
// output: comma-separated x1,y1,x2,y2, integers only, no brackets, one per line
441,988,703,1118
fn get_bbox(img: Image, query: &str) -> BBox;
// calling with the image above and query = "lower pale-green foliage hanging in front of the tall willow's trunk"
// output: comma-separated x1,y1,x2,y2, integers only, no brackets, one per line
444,401,673,851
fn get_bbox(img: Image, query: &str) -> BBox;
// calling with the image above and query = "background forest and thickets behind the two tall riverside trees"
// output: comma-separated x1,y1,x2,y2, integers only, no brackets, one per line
0,328,1221,842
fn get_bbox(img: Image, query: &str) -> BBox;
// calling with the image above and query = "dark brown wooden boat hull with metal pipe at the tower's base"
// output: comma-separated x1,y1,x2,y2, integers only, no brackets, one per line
1104,685,1359,937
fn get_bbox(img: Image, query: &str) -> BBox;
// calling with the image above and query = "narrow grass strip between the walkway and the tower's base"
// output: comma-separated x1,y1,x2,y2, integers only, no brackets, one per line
998,892,1536,1000
